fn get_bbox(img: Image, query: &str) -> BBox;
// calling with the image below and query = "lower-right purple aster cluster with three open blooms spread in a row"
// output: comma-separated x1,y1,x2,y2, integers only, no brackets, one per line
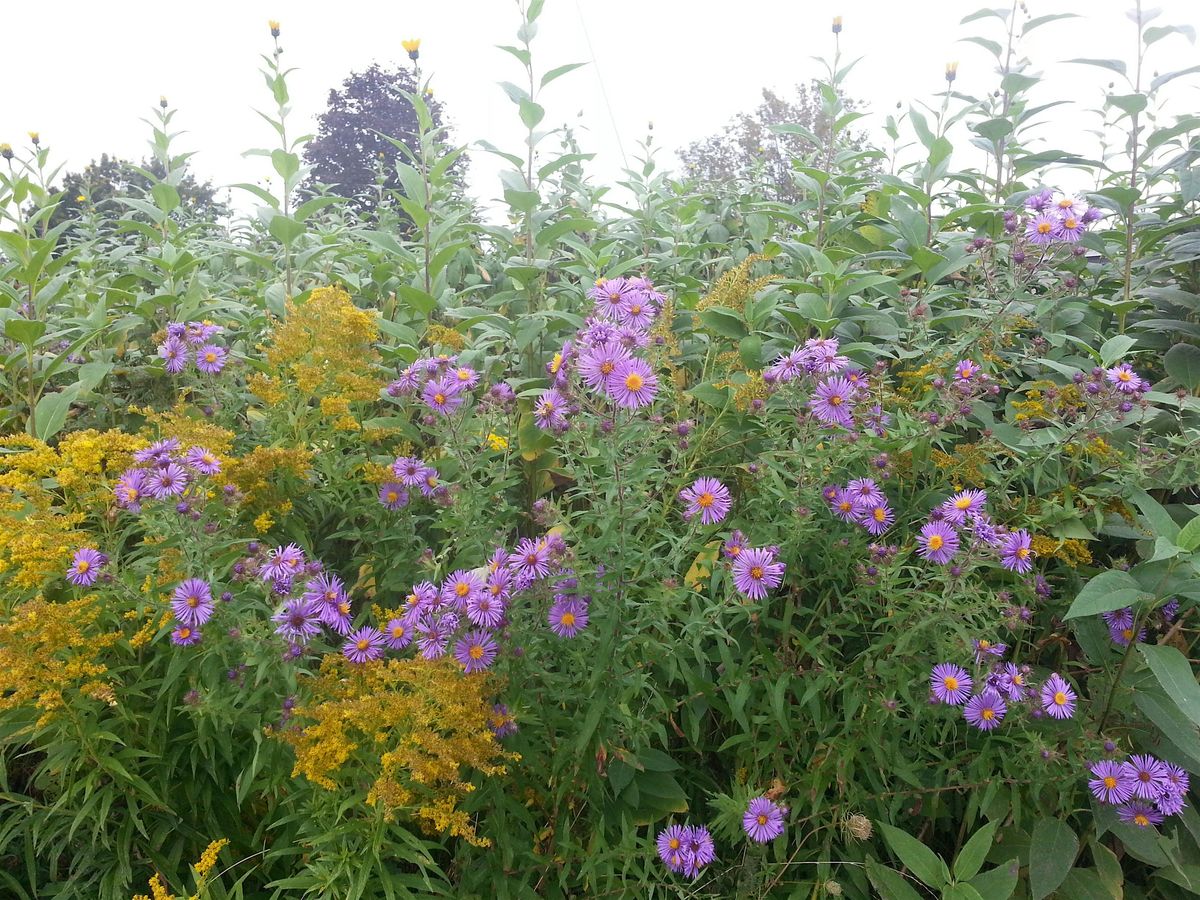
929,640,1078,731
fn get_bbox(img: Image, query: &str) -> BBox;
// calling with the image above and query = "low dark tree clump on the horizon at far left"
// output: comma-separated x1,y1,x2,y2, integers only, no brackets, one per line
50,154,229,227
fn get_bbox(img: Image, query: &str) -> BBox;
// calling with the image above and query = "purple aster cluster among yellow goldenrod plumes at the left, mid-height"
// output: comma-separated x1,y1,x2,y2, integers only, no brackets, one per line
113,438,229,518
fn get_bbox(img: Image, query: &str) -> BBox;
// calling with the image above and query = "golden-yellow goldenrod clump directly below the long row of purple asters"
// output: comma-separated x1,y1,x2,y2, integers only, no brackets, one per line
277,654,514,846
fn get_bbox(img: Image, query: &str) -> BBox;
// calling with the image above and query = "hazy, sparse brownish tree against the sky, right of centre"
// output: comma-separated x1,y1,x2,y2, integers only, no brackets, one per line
679,82,865,203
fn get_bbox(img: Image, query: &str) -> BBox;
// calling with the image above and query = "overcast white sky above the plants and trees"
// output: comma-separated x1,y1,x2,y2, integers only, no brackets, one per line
0,0,1200,212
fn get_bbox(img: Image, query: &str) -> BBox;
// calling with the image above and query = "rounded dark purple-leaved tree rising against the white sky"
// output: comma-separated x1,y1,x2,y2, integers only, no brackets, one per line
305,64,464,212
